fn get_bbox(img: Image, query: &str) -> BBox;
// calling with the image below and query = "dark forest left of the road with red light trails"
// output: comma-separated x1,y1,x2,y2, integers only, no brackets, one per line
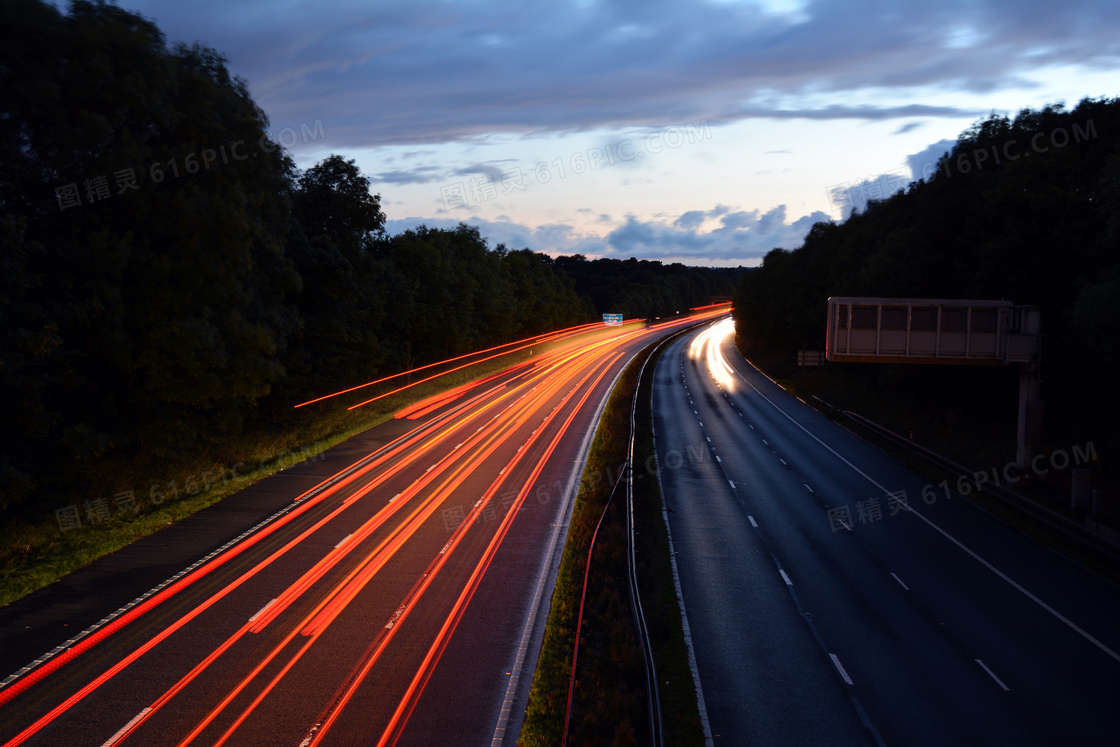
0,0,734,520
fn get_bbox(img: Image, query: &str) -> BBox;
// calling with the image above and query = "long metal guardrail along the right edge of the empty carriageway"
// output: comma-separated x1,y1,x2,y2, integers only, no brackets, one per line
813,395,1120,569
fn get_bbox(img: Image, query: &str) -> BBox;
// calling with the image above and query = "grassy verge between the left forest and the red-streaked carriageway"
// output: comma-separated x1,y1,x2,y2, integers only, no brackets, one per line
0,349,541,606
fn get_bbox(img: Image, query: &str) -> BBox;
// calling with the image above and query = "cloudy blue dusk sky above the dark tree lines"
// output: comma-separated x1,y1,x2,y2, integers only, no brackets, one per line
118,0,1120,267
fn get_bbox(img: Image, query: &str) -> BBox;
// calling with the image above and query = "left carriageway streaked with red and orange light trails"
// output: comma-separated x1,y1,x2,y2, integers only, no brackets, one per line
0,310,715,745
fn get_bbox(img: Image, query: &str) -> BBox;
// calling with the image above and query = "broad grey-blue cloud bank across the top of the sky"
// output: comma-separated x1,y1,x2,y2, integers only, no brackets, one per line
130,0,1120,150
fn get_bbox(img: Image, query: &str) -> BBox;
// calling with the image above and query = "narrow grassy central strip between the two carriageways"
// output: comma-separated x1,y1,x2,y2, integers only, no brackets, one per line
519,338,703,746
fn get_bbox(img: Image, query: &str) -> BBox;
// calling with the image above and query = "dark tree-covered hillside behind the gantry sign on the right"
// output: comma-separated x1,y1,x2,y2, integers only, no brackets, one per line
735,100,1120,459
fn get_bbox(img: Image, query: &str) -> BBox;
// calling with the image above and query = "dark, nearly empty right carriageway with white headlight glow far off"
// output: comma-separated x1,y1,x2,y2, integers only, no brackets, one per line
653,320,1120,745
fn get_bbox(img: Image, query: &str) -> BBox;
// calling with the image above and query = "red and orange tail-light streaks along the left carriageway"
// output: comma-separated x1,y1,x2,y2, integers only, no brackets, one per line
0,307,729,745
